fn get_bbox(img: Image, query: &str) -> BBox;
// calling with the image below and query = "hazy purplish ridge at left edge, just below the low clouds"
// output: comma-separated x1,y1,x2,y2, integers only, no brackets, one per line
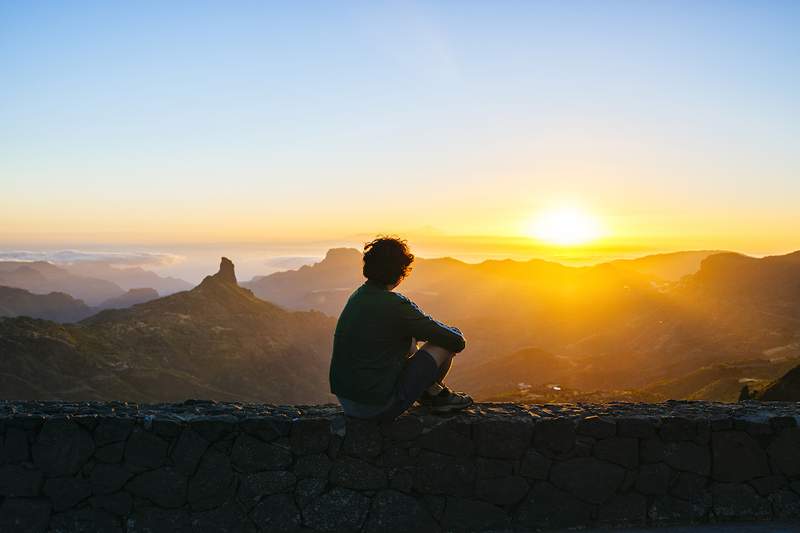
0,261,125,306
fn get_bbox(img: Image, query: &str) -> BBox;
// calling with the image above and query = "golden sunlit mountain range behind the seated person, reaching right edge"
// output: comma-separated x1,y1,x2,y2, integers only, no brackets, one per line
242,245,800,397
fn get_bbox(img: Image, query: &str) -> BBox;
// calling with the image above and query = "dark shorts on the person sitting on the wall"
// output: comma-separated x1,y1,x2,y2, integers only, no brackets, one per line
373,350,453,422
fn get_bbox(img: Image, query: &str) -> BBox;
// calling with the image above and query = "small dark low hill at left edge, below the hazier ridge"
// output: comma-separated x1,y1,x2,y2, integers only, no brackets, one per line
0,286,94,322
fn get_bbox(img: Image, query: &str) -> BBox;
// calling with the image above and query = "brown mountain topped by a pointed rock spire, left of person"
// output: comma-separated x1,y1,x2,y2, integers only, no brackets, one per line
0,258,334,403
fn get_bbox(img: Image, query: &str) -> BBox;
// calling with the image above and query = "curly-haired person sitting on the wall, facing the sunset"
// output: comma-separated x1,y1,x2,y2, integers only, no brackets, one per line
330,237,472,421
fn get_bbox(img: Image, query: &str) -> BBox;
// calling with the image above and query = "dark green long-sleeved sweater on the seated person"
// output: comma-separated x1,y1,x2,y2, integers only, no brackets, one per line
330,281,464,405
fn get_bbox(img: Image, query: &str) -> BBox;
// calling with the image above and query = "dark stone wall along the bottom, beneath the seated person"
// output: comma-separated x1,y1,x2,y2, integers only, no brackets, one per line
0,400,800,532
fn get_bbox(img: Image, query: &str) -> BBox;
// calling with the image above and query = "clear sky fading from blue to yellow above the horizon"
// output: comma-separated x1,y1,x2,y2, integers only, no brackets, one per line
0,0,800,252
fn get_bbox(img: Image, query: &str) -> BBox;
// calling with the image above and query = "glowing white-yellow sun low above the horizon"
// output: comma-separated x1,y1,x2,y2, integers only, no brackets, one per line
526,207,602,246
